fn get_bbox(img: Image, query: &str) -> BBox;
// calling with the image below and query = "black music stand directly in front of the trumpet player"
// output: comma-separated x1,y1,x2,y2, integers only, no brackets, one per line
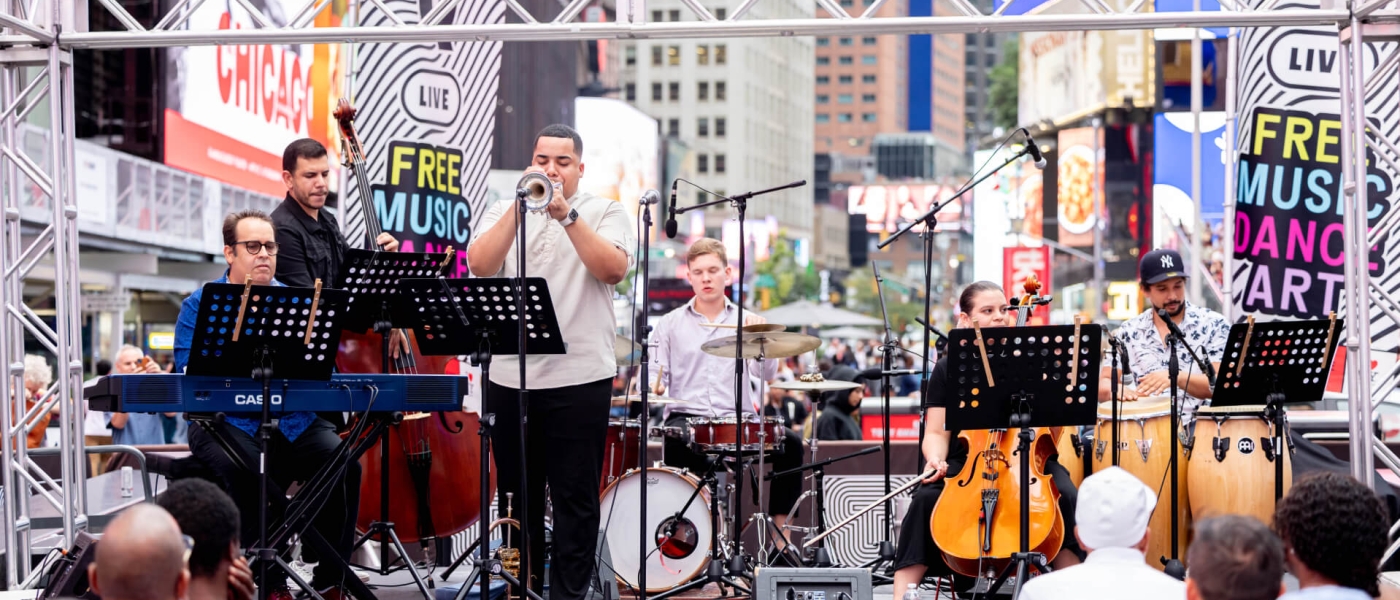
399,277,567,600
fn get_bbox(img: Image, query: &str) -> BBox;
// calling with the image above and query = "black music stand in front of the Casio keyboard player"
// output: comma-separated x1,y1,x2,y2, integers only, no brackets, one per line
186,281,349,599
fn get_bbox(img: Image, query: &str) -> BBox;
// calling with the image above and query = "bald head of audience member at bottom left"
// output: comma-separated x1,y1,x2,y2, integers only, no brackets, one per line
88,503,189,600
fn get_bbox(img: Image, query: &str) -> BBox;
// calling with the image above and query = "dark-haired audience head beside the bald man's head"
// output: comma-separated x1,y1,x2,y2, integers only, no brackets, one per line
155,480,239,587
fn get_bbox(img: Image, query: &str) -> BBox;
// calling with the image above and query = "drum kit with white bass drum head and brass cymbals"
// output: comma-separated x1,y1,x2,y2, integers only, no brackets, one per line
590,323,860,590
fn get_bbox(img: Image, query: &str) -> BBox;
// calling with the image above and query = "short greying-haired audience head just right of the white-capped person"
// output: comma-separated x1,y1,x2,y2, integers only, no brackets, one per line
1186,515,1284,600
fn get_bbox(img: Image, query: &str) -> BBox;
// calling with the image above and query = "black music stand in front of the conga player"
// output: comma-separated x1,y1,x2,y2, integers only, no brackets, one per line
1211,313,1338,505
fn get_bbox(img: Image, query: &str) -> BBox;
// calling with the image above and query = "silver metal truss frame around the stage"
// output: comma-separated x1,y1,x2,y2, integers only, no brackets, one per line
0,0,1400,589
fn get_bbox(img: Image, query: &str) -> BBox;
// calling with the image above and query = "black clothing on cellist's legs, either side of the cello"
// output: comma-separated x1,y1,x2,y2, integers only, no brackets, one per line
895,453,1084,576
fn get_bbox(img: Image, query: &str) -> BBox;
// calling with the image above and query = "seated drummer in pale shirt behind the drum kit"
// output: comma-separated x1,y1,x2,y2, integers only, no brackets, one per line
651,238,802,548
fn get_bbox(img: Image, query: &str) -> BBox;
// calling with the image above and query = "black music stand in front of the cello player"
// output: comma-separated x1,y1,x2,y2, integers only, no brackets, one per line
946,324,1103,597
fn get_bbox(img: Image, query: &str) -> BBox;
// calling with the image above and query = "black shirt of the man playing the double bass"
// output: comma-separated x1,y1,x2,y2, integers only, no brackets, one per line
272,194,350,288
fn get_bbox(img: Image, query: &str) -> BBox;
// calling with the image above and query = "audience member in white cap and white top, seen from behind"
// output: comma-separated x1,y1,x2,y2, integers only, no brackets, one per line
1021,467,1186,600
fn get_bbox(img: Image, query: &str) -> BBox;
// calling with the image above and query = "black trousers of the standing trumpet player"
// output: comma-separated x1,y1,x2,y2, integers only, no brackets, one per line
486,378,612,600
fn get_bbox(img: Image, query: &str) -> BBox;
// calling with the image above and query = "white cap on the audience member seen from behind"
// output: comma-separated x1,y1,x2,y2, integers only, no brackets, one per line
1074,467,1156,550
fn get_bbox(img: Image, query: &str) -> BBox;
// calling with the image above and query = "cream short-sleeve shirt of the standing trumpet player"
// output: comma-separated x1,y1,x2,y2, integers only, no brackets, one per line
468,192,634,390
